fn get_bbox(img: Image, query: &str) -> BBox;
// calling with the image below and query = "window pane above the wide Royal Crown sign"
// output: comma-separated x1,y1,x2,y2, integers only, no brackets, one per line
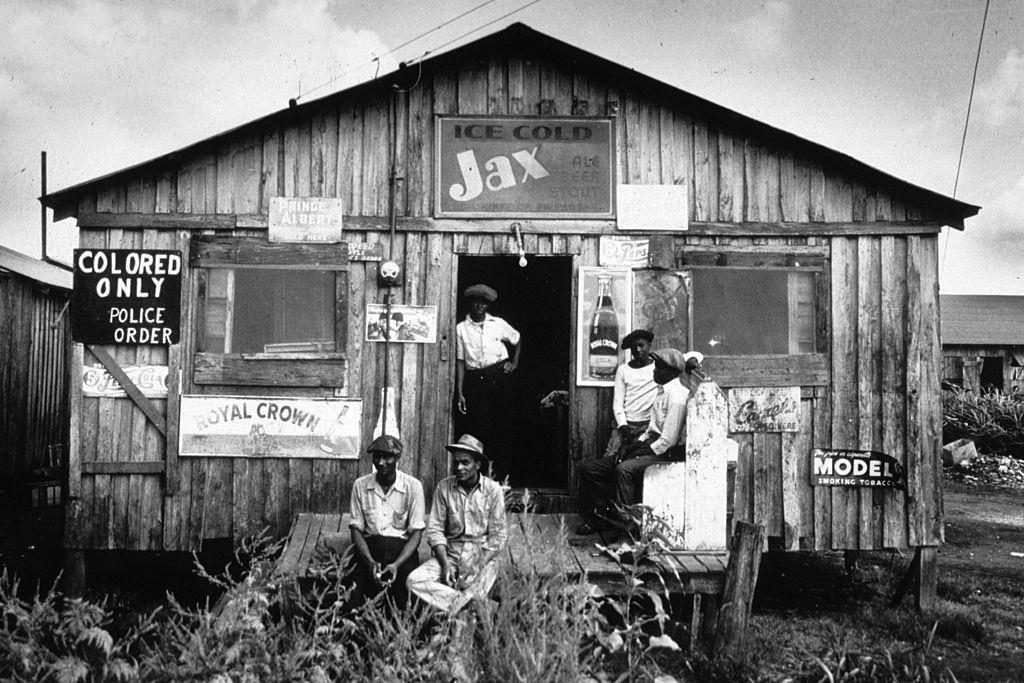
199,268,335,353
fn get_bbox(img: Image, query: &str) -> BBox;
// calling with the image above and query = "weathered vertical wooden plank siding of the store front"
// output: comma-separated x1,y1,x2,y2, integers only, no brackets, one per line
59,48,942,550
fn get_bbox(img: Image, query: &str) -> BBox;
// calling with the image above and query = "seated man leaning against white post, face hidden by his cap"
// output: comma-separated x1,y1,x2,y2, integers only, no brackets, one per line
577,348,702,535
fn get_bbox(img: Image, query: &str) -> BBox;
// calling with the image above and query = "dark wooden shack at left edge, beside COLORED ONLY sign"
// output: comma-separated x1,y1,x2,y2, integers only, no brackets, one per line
0,247,72,508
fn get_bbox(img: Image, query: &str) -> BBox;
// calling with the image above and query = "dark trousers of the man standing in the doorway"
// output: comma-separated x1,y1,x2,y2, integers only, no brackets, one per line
462,361,513,481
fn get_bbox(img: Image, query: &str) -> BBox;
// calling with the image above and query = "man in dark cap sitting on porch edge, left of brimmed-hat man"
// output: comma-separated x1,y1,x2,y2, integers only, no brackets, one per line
346,434,426,607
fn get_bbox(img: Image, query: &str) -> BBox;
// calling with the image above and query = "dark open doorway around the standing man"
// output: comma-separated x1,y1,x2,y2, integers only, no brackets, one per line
454,256,572,489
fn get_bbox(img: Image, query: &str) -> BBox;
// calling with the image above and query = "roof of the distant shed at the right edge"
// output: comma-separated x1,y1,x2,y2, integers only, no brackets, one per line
939,294,1024,346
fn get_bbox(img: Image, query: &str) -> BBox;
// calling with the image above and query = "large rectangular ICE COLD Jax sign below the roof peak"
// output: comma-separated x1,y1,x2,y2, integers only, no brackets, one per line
434,116,615,218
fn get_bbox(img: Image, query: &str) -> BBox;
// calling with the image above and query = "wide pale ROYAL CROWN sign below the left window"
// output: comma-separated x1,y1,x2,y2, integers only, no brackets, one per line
178,394,362,459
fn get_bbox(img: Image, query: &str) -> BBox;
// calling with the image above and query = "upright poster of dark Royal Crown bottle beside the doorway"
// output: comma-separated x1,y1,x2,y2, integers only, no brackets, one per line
577,266,633,386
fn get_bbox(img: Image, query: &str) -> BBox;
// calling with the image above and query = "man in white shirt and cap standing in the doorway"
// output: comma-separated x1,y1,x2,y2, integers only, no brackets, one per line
456,285,521,478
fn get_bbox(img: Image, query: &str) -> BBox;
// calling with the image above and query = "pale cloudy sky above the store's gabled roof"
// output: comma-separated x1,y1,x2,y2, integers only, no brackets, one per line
0,0,1024,295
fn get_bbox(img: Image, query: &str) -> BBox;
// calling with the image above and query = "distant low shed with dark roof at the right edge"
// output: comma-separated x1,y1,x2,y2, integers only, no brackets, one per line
940,294,1024,392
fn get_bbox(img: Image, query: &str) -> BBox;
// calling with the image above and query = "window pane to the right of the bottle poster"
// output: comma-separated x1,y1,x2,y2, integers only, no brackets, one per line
692,268,818,355
